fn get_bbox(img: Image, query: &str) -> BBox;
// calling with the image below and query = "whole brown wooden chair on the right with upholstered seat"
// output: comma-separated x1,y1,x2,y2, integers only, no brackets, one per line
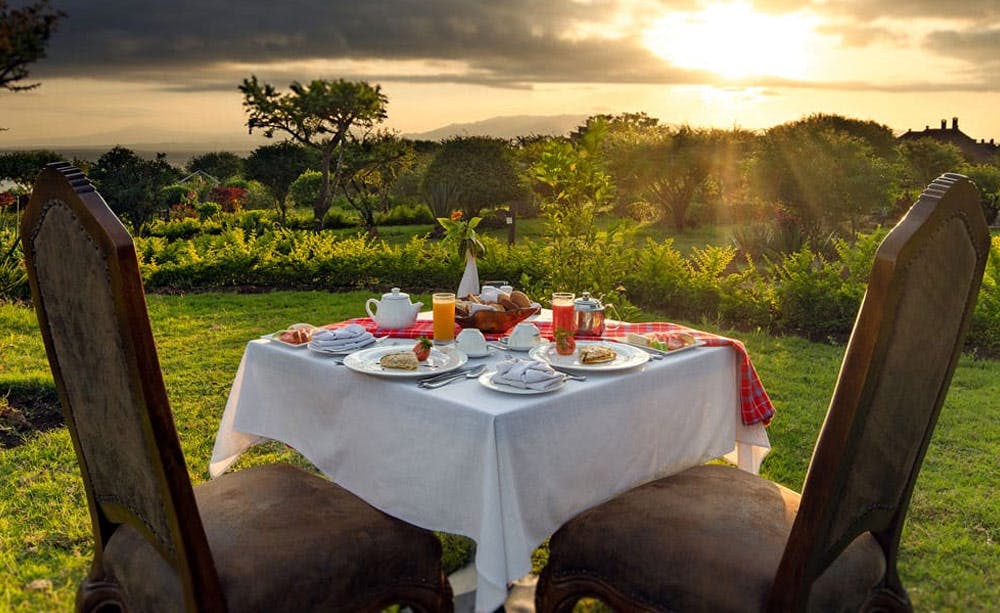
536,174,990,612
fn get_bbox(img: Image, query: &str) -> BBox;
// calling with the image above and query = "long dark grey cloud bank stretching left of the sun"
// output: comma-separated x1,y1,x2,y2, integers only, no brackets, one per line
37,0,690,87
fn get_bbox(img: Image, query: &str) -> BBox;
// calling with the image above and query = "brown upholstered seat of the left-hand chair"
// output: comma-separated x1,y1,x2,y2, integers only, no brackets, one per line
104,464,450,613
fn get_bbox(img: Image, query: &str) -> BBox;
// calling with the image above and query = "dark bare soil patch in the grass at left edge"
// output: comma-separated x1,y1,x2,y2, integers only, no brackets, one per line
0,382,63,449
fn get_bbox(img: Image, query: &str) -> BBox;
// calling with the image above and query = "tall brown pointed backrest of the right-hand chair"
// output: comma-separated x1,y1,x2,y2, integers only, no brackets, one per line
771,174,990,610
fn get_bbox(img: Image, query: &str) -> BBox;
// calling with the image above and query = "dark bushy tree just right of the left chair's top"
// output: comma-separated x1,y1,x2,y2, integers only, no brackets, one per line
90,146,180,231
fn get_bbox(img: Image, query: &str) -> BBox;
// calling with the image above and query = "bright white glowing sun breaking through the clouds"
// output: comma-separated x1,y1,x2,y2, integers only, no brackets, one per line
643,2,815,80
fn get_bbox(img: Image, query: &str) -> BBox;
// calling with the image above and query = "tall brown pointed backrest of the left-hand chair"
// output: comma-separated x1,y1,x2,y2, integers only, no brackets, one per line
21,163,224,610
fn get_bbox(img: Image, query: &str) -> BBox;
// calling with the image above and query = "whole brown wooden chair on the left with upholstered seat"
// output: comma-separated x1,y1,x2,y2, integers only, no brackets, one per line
21,163,452,612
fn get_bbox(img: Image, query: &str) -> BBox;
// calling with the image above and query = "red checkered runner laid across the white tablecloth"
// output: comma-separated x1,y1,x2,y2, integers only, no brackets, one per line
324,317,774,426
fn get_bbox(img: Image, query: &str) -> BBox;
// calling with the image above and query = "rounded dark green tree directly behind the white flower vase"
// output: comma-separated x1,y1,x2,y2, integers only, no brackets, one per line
422,136,522,218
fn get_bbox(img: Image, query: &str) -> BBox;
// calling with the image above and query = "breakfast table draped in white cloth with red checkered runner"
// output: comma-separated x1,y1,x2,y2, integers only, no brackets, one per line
209,310,773,612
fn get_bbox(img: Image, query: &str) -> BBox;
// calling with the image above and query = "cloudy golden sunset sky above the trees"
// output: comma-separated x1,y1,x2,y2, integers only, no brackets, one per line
0,0,1000,147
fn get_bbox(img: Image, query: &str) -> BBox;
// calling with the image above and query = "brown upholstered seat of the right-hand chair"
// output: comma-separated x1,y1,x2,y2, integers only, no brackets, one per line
547,465,885,613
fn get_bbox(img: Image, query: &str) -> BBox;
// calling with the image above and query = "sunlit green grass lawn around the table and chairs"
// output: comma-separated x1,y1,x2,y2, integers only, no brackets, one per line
0,292,1000,611
